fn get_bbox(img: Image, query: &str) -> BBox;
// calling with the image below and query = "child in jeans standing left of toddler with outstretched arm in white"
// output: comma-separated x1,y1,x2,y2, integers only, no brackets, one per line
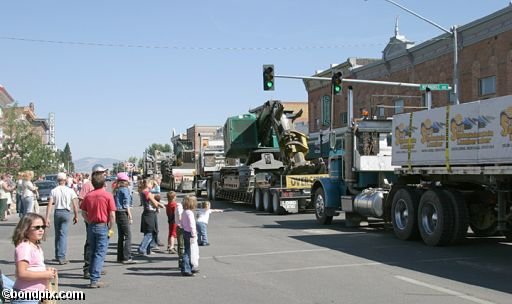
181,195,198,277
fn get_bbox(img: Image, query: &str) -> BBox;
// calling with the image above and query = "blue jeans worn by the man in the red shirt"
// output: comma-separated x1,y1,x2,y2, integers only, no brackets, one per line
87,223,108,283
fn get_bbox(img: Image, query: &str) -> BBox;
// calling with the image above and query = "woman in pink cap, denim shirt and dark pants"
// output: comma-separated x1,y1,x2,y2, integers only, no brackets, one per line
114,172,135,264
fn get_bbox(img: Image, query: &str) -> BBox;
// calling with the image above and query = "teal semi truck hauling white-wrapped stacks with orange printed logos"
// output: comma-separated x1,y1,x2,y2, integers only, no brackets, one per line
311,91,512,246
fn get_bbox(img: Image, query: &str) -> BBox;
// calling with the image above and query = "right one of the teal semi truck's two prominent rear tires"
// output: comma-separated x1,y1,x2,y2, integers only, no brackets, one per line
418,189,454,246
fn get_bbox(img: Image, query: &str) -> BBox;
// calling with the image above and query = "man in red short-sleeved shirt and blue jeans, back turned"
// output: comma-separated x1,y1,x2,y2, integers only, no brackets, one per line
80,174,116,288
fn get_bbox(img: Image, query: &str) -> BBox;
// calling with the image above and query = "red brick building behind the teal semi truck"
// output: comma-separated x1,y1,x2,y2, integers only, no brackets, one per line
304,5,512,157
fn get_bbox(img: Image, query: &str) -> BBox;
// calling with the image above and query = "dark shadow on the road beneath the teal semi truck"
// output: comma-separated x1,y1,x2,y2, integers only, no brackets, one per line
263,220,512,293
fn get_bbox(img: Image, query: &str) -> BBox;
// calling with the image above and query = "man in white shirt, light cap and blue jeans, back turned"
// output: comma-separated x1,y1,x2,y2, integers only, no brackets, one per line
46,172,78,265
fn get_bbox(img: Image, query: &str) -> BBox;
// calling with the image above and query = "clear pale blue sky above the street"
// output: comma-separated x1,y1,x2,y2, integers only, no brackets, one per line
0,0,510,160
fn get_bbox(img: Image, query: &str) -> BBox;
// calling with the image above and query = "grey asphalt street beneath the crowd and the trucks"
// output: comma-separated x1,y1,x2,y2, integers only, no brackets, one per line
0,191,512,304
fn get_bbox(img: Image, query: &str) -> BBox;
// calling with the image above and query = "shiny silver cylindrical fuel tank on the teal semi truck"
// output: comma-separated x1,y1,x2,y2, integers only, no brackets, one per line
354,188,388,218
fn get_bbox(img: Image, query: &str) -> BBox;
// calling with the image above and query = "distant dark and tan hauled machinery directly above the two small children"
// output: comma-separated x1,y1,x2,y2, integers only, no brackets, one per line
160,134,195,192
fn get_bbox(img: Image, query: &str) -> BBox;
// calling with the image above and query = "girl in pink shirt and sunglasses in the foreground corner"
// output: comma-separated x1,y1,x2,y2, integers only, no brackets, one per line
12,213,57,304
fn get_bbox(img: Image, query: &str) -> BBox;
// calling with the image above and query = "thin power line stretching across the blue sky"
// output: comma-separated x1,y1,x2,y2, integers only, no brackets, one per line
0,36,445,51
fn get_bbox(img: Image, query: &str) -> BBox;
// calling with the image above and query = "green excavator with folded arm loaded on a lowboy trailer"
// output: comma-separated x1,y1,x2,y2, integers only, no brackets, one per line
211,100,326,214
